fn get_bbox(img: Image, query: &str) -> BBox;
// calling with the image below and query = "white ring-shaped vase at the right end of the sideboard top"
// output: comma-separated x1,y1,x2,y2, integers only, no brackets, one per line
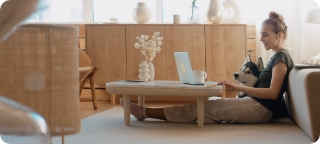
223,0,241,24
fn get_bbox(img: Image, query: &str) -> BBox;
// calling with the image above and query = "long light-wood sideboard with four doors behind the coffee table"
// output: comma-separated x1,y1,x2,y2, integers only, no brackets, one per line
85,24,248,101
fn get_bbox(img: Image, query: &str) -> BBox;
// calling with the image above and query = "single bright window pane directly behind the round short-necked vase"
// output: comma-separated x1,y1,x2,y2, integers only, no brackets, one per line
93,0,157,23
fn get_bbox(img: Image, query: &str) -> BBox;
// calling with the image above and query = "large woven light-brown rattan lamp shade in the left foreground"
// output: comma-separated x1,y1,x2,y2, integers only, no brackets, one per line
0,24,81,136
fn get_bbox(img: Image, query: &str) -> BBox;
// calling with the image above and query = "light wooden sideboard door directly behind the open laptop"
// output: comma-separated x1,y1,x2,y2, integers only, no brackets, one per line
165,25,205,80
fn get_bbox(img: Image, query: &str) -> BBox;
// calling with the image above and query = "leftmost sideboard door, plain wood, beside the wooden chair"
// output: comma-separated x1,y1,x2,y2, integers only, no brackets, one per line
86,25,126,88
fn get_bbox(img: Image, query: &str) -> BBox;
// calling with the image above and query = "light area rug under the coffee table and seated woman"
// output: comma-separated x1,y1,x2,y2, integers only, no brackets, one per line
52,107,313,144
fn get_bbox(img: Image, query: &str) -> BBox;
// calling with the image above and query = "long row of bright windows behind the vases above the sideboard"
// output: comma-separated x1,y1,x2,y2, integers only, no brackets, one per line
0,0,260,24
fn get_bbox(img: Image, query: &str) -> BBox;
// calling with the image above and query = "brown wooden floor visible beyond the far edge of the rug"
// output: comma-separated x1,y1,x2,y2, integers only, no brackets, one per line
80,101,185,118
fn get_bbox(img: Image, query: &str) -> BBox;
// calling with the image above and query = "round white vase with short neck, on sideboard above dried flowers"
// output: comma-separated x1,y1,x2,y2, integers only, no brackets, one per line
132,2,152,24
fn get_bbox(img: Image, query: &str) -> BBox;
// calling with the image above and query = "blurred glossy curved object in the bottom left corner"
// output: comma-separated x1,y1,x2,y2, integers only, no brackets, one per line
0,96,51,144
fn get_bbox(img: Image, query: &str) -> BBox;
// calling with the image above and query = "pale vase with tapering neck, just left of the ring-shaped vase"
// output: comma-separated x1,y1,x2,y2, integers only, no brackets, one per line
205,0,224,24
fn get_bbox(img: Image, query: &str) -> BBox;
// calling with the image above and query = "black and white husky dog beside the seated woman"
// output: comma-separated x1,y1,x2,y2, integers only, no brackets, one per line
233,54,264,98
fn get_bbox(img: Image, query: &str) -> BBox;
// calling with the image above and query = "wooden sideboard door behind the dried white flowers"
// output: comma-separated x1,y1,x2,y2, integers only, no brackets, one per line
126,25,166,80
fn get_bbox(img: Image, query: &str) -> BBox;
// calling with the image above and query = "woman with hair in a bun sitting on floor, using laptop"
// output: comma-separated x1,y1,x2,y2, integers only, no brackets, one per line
120,11,293,124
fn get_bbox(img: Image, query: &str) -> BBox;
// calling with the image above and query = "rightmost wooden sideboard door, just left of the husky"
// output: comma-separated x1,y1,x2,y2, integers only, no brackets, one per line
205,25,246,81
